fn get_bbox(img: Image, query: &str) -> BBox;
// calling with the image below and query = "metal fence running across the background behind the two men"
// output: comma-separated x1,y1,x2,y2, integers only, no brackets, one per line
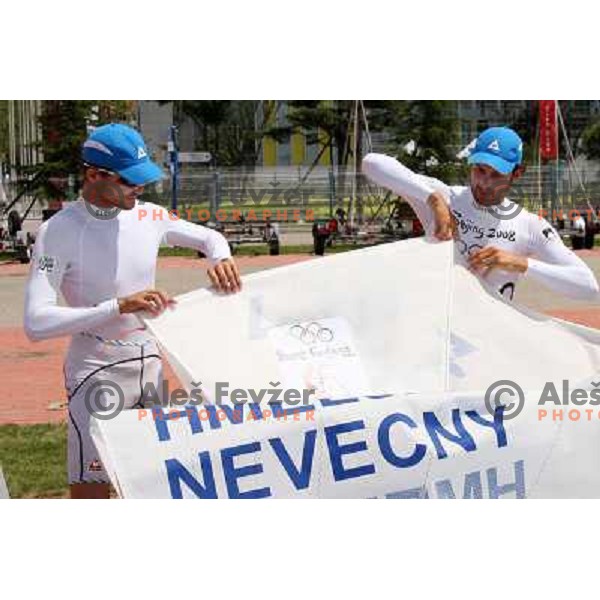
7,162,600,222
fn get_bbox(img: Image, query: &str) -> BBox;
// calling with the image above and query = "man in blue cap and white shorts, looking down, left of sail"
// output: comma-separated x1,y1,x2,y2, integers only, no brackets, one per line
24,124,241,498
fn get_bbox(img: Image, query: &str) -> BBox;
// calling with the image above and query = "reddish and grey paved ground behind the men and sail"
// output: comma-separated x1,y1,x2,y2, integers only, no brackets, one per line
0,250,600,424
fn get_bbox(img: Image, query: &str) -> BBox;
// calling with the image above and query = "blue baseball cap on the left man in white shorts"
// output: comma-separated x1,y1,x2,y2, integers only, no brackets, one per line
81,123,163,185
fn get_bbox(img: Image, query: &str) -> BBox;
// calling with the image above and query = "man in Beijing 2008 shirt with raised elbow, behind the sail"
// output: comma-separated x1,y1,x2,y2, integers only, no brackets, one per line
362,127,599,300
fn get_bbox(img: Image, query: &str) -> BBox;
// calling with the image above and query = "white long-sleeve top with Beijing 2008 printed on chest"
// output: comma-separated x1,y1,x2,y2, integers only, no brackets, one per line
362,153,600,300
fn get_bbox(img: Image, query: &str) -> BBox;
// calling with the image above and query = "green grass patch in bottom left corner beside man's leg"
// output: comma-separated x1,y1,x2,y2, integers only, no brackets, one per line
0,424,68,498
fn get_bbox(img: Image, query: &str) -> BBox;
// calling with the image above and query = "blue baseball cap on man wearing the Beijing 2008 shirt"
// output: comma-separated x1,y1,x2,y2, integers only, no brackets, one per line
469,127,523,175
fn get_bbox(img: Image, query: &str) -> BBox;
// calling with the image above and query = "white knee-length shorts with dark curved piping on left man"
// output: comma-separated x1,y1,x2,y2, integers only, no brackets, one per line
64,334,163,484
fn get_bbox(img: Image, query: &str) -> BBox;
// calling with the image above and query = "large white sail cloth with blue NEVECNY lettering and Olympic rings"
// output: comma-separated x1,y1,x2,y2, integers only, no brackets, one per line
92,239,600,498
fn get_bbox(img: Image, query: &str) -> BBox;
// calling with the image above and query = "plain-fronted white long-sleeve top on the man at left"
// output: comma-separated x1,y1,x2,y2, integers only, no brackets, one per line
24,199,231,340
